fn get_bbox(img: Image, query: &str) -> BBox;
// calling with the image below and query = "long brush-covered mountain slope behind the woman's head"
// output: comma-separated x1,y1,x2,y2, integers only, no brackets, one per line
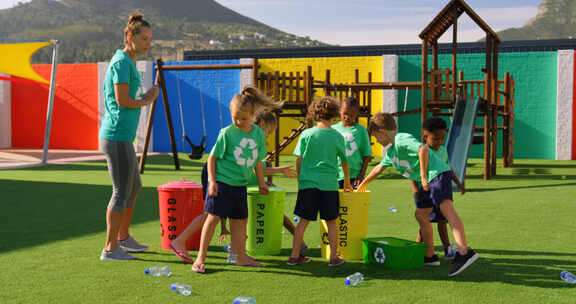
0,0,326,63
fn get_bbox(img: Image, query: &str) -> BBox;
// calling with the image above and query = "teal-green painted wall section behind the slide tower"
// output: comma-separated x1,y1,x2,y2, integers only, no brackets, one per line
398,52,558,159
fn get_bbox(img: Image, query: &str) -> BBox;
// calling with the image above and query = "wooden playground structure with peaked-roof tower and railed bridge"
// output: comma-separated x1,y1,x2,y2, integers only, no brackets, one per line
255,0,515,180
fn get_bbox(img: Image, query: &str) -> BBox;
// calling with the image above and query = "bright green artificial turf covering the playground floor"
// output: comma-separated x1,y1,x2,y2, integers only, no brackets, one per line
0,155,576,304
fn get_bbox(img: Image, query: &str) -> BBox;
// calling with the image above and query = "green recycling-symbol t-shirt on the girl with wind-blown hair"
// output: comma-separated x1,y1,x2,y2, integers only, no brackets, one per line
210,124,266,187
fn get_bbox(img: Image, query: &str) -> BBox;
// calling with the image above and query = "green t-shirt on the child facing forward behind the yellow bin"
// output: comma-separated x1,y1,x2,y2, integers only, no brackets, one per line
332,122,372,180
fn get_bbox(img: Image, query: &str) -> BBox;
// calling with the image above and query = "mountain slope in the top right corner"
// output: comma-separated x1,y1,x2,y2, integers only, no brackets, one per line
498,0,576,40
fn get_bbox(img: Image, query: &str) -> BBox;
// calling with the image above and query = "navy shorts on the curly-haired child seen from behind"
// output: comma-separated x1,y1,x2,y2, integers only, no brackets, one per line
294,188,340,221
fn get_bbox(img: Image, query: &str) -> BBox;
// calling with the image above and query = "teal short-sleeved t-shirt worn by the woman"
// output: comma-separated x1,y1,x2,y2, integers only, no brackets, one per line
100,50,140,142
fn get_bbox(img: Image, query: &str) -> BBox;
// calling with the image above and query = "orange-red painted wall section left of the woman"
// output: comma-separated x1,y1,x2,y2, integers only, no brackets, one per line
12,63,98,150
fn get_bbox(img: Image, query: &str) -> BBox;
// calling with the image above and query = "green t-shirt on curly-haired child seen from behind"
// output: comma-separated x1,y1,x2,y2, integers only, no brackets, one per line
294,127,348,191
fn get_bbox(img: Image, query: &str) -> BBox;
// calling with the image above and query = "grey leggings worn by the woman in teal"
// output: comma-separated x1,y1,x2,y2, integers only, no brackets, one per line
100,139,142,213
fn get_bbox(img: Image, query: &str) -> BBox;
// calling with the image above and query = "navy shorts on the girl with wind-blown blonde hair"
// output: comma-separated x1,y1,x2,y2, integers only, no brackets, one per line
204,182,248,220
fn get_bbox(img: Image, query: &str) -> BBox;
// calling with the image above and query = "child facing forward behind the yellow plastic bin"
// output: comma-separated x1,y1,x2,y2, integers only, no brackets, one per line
332,97,372,188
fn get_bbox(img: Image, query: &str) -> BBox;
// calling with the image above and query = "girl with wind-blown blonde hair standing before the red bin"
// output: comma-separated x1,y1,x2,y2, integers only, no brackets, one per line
192,87,280,273
